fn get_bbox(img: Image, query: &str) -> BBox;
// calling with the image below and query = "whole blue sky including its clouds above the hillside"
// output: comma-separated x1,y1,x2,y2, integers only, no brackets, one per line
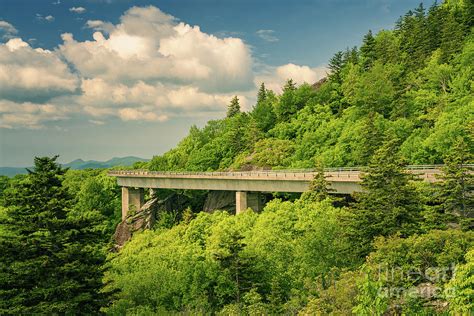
0,0,426,166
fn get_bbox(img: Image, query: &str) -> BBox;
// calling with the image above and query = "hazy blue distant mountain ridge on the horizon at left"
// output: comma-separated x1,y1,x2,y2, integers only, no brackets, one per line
0,156,149,177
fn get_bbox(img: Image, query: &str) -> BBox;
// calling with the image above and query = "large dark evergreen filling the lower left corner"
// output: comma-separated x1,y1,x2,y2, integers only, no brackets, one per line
0,156,106,315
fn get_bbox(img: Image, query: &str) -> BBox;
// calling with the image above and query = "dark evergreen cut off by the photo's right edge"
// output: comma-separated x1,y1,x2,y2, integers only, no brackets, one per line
438,137,474,228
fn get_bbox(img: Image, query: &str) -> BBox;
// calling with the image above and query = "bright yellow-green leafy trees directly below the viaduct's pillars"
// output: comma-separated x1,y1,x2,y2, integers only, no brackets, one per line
107,200,350,313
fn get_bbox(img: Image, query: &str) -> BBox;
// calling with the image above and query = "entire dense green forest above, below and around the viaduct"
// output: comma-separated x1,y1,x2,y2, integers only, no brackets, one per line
0,0,474,315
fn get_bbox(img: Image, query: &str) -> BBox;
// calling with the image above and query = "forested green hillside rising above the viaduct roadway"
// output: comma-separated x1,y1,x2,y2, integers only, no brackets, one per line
147,1,474,171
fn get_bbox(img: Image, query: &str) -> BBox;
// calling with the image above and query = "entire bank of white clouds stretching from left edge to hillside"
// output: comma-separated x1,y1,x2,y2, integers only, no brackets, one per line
0,6,322,128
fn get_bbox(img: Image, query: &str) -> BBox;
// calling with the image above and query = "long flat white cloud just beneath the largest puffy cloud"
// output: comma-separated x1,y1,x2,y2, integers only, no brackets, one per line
77,78,247,121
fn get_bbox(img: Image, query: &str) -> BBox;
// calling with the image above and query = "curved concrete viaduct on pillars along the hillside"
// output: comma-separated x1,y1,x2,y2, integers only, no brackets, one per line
109,165,441,219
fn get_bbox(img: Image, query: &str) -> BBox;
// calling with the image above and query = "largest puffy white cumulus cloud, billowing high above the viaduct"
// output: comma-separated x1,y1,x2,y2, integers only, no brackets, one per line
60,6,253,92
